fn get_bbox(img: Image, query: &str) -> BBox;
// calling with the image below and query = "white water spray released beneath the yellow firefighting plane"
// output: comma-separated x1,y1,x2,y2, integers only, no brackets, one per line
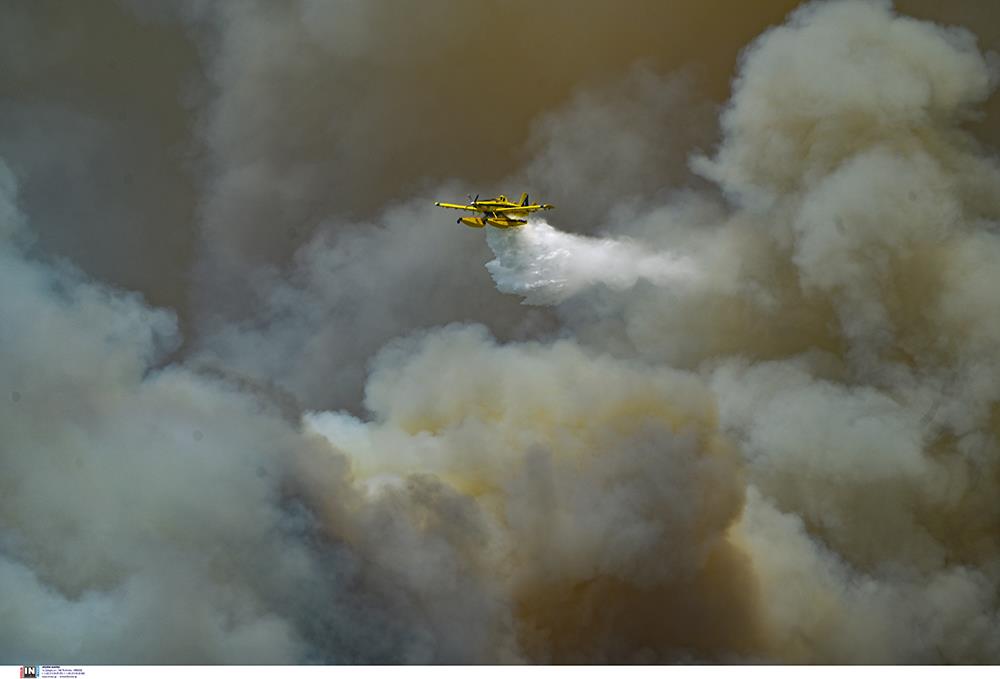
486,221,698,305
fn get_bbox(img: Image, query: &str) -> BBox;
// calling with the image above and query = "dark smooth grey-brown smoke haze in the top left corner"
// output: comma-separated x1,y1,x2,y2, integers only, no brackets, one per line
0,0,201,319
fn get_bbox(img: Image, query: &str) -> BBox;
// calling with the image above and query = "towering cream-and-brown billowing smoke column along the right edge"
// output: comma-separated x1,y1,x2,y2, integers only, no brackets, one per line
524,2,1000,662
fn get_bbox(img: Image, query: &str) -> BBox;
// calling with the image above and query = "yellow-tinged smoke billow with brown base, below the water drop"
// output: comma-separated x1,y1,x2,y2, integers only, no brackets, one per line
308,327,757,662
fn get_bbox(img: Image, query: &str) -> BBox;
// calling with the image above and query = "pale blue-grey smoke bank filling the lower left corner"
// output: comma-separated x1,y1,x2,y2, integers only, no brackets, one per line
0,166,536,663
